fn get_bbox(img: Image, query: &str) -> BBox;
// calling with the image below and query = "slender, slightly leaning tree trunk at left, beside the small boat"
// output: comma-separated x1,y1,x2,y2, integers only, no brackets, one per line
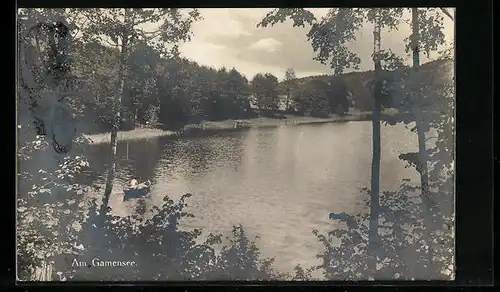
100,8,128,218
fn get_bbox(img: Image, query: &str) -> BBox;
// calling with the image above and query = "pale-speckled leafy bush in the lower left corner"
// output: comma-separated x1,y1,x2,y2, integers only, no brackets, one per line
16,132,91,280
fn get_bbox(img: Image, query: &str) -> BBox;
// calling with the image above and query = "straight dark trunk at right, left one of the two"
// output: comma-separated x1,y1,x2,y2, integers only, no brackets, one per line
368,11,382,274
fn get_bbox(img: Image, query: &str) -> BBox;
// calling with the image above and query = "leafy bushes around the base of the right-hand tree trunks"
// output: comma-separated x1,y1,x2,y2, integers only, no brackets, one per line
314,183,454,281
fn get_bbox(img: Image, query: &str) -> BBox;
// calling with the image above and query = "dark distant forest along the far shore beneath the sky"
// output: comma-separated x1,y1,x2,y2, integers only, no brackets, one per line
73,43,349,133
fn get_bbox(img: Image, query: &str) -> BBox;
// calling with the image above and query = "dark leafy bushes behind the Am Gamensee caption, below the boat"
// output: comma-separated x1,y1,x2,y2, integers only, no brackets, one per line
54,194,285,281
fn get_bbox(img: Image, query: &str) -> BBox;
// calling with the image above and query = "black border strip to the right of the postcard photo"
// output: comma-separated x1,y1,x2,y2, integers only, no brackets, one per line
456,1,494,286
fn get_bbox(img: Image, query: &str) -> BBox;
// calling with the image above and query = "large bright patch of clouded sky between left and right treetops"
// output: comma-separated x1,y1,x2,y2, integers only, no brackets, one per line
180,8,331,78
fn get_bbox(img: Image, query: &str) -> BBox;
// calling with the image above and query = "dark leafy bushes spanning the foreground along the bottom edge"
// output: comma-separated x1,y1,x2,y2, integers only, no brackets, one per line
18,184,453,281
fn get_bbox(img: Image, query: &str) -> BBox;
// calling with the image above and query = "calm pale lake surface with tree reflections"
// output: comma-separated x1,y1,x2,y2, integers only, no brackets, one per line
87,122,417,271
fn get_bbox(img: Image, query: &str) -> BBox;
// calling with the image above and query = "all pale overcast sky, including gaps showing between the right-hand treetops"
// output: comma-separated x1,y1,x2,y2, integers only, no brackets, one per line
180,8,453,79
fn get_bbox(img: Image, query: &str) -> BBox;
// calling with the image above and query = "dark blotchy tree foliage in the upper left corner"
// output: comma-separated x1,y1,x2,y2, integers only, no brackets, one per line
18,9,81,154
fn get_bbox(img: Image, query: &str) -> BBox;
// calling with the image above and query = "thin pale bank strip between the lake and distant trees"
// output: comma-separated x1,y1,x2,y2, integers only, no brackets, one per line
83,112,371,144
